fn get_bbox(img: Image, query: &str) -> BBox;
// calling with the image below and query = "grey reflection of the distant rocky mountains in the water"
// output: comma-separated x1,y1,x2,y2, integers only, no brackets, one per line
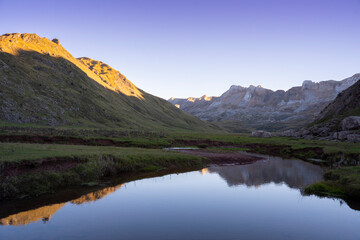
209,157,323,189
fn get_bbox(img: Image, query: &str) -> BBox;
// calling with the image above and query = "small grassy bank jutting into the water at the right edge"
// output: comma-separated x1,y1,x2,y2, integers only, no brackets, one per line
305,166,360,200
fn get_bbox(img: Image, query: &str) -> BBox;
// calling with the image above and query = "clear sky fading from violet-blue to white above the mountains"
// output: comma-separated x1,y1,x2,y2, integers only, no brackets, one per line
0,0,360,99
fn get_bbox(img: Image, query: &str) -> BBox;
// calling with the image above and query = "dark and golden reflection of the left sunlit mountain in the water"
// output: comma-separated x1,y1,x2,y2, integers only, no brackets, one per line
0,169,195,226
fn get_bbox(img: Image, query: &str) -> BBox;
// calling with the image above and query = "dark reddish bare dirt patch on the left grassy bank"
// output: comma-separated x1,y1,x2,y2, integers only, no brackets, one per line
0,157,83,178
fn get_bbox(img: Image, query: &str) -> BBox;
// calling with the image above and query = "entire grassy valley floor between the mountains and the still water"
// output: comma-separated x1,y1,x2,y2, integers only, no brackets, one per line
0,127,360,200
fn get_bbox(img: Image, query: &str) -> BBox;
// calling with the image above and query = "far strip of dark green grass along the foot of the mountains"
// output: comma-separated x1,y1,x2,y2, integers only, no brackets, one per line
0,126,360,154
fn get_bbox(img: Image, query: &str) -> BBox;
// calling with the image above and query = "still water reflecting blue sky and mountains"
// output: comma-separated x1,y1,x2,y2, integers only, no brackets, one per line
0,157,360,240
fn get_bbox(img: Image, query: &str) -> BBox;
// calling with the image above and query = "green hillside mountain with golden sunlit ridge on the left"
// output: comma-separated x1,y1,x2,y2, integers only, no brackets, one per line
0,33,213,130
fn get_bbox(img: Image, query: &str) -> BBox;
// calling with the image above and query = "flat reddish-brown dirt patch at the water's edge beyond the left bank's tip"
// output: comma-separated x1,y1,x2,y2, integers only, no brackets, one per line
177,149,263,165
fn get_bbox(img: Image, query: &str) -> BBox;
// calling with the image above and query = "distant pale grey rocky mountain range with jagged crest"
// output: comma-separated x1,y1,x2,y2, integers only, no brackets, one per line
168,74,360,131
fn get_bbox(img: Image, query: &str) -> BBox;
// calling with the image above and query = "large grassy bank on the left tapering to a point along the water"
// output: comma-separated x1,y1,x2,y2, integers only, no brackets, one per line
0,143,205,200
